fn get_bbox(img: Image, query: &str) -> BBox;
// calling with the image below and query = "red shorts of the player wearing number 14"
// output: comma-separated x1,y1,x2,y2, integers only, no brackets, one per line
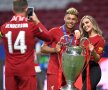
5,75,37,90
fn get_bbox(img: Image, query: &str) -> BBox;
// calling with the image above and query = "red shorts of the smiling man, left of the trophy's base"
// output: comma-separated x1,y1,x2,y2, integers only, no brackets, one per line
47,74,66,90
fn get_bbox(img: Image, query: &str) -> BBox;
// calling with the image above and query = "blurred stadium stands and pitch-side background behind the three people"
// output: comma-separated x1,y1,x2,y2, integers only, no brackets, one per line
0,0,108,90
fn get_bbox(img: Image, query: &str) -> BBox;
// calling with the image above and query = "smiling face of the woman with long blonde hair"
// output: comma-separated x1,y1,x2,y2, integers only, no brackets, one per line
82,18,93,33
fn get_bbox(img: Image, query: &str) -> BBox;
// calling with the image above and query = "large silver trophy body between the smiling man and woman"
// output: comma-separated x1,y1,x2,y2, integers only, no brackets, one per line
60,36,90,90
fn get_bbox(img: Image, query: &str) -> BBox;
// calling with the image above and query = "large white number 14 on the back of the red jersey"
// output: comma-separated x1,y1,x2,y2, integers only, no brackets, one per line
5,31,27,54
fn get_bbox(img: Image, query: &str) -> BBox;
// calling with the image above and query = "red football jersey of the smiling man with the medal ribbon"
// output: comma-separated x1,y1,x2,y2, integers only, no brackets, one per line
46,27,78,74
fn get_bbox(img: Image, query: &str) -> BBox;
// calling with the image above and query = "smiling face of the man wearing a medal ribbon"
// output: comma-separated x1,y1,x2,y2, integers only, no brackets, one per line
64,14,77,29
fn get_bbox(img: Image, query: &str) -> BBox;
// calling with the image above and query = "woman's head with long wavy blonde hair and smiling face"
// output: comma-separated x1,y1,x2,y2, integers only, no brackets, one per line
79,15,102,37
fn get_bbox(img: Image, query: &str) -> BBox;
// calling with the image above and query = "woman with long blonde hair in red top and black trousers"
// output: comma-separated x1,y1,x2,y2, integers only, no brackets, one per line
79,15,105,90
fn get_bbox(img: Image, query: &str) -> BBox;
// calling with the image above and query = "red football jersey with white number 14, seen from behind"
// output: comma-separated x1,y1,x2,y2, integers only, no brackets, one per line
1,16,50,75
